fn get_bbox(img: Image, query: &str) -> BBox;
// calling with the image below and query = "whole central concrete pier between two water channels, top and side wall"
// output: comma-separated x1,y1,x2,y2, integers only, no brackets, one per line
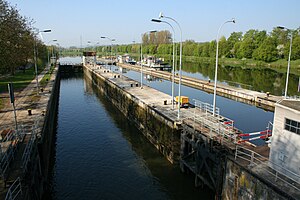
83,64,300,199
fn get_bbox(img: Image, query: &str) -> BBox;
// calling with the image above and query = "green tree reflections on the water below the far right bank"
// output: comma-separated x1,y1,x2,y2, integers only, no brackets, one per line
183,62,299,96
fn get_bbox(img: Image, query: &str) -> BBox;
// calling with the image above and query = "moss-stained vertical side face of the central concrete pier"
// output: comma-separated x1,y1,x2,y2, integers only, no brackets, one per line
83,67,180,163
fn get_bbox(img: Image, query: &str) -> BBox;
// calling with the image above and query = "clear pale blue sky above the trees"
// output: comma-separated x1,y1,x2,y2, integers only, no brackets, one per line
7,0,300,47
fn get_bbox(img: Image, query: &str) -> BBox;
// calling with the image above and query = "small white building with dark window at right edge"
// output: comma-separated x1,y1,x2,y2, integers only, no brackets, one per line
269,99,300,183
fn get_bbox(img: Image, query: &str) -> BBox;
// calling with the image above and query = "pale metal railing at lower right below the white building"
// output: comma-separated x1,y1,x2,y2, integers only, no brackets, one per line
235,145,300,192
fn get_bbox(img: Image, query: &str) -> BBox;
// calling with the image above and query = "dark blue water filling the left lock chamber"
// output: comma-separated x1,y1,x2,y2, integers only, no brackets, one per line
48,75,214,200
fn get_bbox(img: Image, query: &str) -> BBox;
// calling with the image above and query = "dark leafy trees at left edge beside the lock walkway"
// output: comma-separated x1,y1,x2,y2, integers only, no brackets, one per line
0,0,47,75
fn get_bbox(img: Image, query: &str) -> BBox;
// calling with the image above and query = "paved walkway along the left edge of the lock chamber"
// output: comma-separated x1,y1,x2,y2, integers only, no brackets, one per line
0,65,57,199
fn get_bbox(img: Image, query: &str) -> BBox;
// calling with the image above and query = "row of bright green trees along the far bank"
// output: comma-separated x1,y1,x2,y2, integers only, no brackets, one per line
93,27,300,62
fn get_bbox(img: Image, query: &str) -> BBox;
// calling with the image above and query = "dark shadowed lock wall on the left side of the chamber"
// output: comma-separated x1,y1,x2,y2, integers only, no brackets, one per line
24,67,60,199
